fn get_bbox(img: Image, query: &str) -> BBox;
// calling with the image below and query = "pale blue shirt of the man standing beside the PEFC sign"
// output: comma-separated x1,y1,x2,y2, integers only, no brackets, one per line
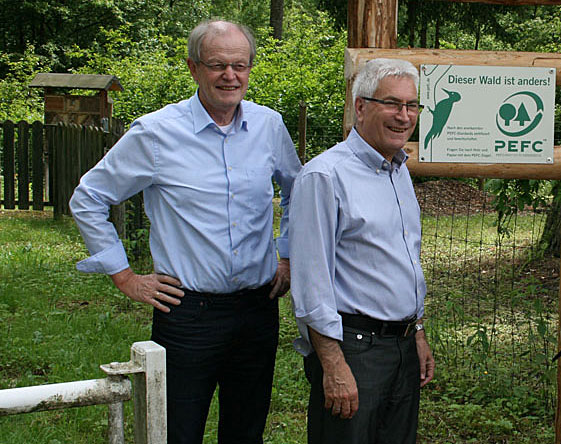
290,129,426,355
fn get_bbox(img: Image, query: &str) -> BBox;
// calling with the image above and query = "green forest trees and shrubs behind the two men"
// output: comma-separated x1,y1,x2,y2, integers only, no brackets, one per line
0,0,561,246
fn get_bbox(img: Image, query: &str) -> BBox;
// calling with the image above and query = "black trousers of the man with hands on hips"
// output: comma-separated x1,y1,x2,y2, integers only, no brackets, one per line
152,287,279,444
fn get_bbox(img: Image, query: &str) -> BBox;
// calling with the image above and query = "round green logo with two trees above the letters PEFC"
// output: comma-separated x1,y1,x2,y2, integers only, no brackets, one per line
496,91,544,137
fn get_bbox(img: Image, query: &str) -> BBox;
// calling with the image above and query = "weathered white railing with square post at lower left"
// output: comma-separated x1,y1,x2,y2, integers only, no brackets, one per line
0,341,167,444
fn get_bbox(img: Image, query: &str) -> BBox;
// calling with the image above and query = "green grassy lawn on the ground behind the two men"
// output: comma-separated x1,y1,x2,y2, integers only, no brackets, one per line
0,211,558,444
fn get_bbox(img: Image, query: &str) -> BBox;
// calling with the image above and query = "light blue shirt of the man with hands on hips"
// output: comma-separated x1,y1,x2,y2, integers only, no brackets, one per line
70,94,301,293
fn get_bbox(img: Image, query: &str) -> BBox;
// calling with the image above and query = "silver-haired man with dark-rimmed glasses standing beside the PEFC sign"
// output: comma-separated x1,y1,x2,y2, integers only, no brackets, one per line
290,59,434,444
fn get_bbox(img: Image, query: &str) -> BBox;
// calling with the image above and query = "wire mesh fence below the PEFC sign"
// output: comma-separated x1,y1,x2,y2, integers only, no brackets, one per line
416,180,559,420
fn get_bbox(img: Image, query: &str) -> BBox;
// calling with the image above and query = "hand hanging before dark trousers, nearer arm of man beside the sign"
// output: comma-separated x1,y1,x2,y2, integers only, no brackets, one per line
308,328,358,419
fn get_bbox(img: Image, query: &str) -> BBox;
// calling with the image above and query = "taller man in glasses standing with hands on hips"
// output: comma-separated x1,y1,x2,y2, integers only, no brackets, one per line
71,21,301,444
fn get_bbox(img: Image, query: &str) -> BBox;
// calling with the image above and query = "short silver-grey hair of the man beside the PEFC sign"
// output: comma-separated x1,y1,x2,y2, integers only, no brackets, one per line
353,58,419,103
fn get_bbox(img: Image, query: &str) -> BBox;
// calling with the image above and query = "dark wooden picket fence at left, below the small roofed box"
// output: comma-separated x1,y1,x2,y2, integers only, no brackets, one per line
0,120,124,217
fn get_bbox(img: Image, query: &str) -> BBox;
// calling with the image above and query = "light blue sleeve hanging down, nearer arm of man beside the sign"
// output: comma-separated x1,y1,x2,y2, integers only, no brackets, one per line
289,171,343,354
